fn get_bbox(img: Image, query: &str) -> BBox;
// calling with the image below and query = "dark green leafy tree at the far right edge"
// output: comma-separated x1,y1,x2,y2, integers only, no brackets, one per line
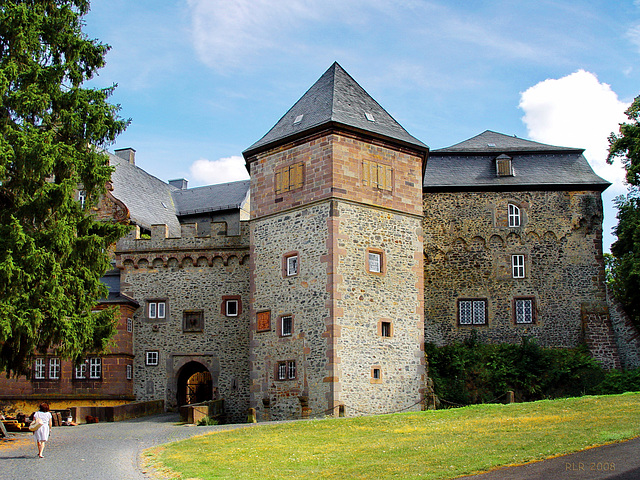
607,96,640,328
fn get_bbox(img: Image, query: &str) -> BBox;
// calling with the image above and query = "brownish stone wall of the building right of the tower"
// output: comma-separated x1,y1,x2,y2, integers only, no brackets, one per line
424,191,606,347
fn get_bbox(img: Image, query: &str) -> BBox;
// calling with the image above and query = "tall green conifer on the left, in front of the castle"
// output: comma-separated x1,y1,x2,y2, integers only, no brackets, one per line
0,0,127,376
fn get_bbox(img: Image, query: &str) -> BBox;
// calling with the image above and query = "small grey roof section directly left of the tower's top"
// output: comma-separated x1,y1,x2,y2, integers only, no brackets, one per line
172,180,250,216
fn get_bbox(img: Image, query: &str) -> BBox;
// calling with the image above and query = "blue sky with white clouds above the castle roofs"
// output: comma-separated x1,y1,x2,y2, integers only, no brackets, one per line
84,0,640,248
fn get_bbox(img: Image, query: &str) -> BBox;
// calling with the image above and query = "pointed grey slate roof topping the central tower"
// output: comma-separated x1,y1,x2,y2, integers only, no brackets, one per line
243,62,428,159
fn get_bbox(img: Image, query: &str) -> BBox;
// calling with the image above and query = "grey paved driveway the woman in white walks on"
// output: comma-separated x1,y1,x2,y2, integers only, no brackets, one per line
0,414,247,480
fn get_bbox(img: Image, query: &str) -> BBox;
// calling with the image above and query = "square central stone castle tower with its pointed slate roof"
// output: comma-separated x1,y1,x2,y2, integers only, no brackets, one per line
243,63,428,420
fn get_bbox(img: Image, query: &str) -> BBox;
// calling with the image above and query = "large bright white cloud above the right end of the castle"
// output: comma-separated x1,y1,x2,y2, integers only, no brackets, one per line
520,70,629,250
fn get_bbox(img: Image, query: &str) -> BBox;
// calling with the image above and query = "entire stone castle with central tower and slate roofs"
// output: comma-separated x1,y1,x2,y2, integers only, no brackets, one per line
2,64,640,421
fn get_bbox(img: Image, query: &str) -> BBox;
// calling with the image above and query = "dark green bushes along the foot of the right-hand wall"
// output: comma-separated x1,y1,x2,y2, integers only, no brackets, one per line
425,337,616,406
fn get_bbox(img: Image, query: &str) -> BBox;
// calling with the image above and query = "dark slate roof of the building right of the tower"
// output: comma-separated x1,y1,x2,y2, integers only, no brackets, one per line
423,130,610,191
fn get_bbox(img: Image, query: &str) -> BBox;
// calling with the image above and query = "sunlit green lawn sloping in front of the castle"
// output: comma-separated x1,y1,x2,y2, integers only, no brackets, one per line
145,393,640,480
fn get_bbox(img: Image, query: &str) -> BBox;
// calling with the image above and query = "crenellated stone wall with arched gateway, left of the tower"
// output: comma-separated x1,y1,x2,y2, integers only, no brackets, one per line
116,223,249,422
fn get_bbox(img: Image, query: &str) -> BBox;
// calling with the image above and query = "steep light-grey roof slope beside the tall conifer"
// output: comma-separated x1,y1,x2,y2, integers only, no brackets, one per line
109,154,180,237
